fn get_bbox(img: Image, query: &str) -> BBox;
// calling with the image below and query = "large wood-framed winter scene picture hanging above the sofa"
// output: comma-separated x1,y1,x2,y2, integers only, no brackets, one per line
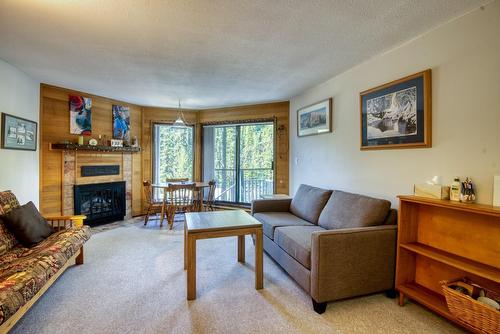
360,69,431,150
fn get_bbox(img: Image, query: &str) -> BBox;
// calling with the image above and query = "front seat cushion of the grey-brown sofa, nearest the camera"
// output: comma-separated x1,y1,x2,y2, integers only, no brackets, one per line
274,225,325,269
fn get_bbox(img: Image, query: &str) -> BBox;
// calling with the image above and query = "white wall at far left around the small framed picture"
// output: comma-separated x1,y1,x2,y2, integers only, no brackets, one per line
0,60,40,207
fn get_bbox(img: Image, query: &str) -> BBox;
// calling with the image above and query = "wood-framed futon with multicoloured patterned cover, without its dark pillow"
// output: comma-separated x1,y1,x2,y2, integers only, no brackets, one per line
0,191,91,333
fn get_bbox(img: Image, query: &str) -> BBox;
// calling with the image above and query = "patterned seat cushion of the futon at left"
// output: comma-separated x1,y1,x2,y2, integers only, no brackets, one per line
0,226,90,324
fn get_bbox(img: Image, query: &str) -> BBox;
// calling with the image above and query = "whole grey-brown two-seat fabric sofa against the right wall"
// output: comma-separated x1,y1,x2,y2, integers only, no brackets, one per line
252,185,397,313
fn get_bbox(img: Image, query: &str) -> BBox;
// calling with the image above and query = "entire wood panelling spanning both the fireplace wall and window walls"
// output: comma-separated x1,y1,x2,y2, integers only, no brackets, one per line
40,84,289,216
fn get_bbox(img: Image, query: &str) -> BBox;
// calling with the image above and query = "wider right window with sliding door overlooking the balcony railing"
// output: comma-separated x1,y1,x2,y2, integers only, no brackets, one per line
203,122,274,204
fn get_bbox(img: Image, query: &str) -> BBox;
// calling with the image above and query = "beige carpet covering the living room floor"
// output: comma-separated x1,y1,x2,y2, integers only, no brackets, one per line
12,218,462,334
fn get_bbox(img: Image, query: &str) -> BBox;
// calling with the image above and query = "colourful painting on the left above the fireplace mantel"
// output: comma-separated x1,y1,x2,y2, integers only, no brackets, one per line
69,95,92,135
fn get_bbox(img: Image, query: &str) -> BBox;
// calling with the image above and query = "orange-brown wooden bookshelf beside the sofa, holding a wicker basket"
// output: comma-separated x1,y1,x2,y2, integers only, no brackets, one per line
396,196,500,332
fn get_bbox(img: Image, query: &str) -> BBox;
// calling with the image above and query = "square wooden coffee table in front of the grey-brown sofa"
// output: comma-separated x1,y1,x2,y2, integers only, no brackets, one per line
184,210,264,300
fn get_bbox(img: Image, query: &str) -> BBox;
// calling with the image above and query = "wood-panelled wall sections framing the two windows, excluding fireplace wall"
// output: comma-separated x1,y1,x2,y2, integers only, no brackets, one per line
142,101,289,194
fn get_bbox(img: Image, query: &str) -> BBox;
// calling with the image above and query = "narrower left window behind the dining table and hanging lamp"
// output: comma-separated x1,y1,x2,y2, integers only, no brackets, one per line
153,123,193,198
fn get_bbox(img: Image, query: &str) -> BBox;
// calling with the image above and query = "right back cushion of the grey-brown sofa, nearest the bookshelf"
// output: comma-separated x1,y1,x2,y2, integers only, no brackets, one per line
318,190,391,230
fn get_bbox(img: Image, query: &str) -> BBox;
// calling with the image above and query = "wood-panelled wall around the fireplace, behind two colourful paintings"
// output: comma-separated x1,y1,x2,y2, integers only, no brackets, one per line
40,84,142,215
